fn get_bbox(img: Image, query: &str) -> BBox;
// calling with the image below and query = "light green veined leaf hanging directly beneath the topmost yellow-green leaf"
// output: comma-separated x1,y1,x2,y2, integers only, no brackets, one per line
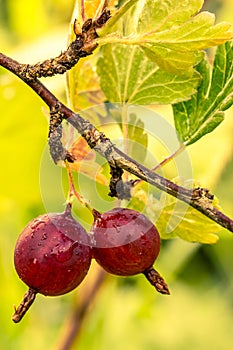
97,45,199,104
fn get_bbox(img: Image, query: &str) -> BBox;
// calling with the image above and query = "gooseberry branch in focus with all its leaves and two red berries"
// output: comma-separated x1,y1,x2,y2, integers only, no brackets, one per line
0,0,233,336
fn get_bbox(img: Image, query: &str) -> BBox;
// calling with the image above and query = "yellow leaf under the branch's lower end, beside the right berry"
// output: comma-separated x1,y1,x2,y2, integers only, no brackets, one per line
129,183,220,244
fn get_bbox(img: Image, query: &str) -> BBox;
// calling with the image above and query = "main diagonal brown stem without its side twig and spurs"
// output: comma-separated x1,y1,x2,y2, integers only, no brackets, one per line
0,53,233,232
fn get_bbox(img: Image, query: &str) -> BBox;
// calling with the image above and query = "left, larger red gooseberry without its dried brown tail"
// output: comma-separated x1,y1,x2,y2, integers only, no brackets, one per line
14,206,91,322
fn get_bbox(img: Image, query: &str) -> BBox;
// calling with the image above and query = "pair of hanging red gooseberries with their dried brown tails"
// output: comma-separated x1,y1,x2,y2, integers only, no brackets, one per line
13,204,169,322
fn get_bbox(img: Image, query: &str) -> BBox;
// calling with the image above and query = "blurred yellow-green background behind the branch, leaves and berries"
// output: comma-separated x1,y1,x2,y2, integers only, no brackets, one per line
0,0,233,350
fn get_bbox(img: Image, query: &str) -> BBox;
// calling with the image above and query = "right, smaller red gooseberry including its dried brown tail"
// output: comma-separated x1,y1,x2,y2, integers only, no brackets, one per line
91,208,169,294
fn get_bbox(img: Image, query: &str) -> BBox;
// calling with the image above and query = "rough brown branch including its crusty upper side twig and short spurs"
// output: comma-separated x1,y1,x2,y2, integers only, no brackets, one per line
0,9,233,232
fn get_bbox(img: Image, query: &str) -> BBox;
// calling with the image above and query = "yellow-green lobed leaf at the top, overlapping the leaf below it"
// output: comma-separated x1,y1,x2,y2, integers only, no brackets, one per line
99,0,233,76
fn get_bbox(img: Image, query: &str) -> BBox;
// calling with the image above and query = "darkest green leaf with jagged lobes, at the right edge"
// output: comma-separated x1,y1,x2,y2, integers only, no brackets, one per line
173,42,233,145
